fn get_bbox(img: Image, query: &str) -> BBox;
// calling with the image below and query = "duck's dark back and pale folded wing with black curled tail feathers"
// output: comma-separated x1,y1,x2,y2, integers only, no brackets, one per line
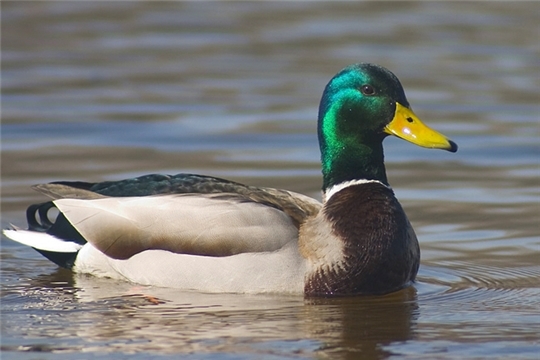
27,174,321,259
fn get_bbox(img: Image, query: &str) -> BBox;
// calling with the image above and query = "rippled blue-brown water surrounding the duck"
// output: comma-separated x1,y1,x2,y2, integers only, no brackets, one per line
0,2,540,360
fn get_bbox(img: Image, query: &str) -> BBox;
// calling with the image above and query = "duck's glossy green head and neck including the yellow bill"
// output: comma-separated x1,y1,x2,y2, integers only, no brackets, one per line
318,64,457,189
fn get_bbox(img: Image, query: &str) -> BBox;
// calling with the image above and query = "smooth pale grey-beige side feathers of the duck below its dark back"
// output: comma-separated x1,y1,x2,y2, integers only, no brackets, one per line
54,194,298,259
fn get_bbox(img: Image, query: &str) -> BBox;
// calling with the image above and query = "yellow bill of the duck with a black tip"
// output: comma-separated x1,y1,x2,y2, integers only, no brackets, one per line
384,103,457,152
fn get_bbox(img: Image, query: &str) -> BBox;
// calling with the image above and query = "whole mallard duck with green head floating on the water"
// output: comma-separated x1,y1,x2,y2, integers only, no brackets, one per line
3,63,457,297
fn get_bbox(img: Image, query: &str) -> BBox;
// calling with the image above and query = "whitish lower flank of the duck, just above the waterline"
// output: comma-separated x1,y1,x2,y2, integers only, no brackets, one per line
73,242,306,294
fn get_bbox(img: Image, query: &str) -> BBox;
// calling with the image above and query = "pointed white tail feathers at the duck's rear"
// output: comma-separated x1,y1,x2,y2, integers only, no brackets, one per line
3,228,83,253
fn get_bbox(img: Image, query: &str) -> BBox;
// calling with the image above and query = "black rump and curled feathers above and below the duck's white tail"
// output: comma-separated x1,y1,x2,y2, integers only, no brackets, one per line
26,201,86,269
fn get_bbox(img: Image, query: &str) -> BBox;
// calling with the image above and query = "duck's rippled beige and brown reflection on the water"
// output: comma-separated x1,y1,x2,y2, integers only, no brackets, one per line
17,270,418,359
